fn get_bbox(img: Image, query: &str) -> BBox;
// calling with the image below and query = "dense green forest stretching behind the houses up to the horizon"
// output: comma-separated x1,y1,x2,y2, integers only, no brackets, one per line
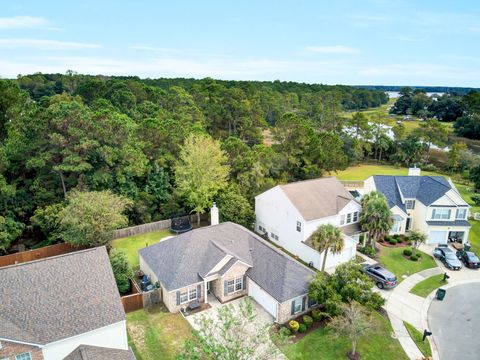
0,72,387,251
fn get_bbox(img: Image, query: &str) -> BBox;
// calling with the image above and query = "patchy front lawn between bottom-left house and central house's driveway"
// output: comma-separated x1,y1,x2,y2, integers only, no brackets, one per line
127,305,192,360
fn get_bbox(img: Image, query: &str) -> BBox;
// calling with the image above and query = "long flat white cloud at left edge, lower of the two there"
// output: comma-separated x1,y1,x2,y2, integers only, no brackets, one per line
0,39,101,50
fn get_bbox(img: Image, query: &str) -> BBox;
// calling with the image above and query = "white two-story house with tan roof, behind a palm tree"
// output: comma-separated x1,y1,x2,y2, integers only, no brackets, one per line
255,177,361,269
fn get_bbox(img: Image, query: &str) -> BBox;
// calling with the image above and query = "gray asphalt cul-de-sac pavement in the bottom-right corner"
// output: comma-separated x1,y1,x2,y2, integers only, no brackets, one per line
428,282,480,360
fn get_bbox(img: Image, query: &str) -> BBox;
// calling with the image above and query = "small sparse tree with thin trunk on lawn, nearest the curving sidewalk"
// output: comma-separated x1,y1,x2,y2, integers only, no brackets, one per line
328,302,373,359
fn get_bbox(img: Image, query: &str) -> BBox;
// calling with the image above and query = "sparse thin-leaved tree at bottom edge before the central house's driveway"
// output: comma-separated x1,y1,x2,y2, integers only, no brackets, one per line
177,298,284,360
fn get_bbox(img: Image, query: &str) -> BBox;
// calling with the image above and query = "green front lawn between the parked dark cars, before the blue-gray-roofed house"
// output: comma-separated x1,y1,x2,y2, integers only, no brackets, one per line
377,245,437,282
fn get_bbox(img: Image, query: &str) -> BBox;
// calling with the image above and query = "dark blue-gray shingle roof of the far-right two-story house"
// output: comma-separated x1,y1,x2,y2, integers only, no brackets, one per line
373,175,452,211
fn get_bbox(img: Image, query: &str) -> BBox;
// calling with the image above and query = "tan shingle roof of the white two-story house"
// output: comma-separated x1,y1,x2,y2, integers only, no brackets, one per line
280,177,355,221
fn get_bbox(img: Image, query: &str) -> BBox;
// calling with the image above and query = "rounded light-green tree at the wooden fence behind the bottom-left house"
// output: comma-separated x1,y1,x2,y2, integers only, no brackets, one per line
59,191,131,247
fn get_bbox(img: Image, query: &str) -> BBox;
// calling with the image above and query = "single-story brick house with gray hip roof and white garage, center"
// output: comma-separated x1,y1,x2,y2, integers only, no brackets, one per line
139,222,315,323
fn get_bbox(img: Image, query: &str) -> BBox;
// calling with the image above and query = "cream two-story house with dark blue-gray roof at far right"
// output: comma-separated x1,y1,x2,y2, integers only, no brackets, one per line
363,168,470,244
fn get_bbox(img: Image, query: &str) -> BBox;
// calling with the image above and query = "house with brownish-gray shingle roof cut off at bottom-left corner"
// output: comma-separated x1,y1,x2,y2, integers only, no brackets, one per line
0,247,128,360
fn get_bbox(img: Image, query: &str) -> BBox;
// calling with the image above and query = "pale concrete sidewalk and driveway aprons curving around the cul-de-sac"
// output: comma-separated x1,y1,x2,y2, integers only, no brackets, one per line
380,245,480,360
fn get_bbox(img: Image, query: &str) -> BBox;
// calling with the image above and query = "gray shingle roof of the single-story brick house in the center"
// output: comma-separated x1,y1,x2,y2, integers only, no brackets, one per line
139,222,314,302
